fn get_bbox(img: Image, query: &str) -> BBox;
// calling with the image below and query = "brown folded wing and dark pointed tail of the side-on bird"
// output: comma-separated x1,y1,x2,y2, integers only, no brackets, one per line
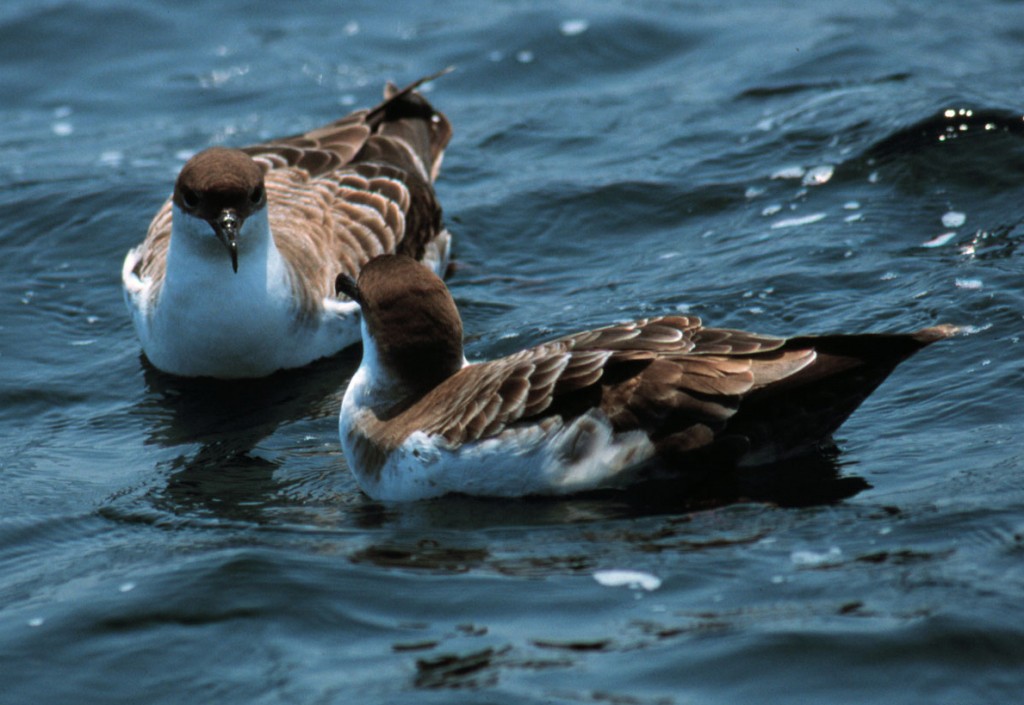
385,317,954,463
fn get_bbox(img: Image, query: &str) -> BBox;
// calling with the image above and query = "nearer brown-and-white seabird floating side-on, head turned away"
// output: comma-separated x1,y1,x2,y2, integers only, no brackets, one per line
339,255,956,501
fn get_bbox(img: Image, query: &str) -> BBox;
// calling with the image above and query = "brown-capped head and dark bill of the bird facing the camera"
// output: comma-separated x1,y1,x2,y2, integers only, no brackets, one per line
171,147,266,272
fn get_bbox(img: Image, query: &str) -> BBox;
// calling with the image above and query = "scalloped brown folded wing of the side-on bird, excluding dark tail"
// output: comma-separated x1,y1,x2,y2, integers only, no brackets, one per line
394,317,813,444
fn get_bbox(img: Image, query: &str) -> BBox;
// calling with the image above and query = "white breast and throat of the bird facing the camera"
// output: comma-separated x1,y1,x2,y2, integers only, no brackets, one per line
125,208,358,378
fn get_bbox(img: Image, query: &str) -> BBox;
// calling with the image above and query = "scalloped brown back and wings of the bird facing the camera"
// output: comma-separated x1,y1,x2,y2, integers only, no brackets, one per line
134,75,452,314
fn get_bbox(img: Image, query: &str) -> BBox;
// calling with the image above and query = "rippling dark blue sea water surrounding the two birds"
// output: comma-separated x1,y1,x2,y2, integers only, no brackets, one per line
0,0,1024,705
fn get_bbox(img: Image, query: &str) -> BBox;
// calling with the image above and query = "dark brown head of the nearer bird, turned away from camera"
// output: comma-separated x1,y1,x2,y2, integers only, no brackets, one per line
337,254,464,395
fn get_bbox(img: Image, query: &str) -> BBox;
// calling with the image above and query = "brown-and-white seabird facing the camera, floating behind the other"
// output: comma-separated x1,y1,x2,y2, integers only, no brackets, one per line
122,72,452,378
